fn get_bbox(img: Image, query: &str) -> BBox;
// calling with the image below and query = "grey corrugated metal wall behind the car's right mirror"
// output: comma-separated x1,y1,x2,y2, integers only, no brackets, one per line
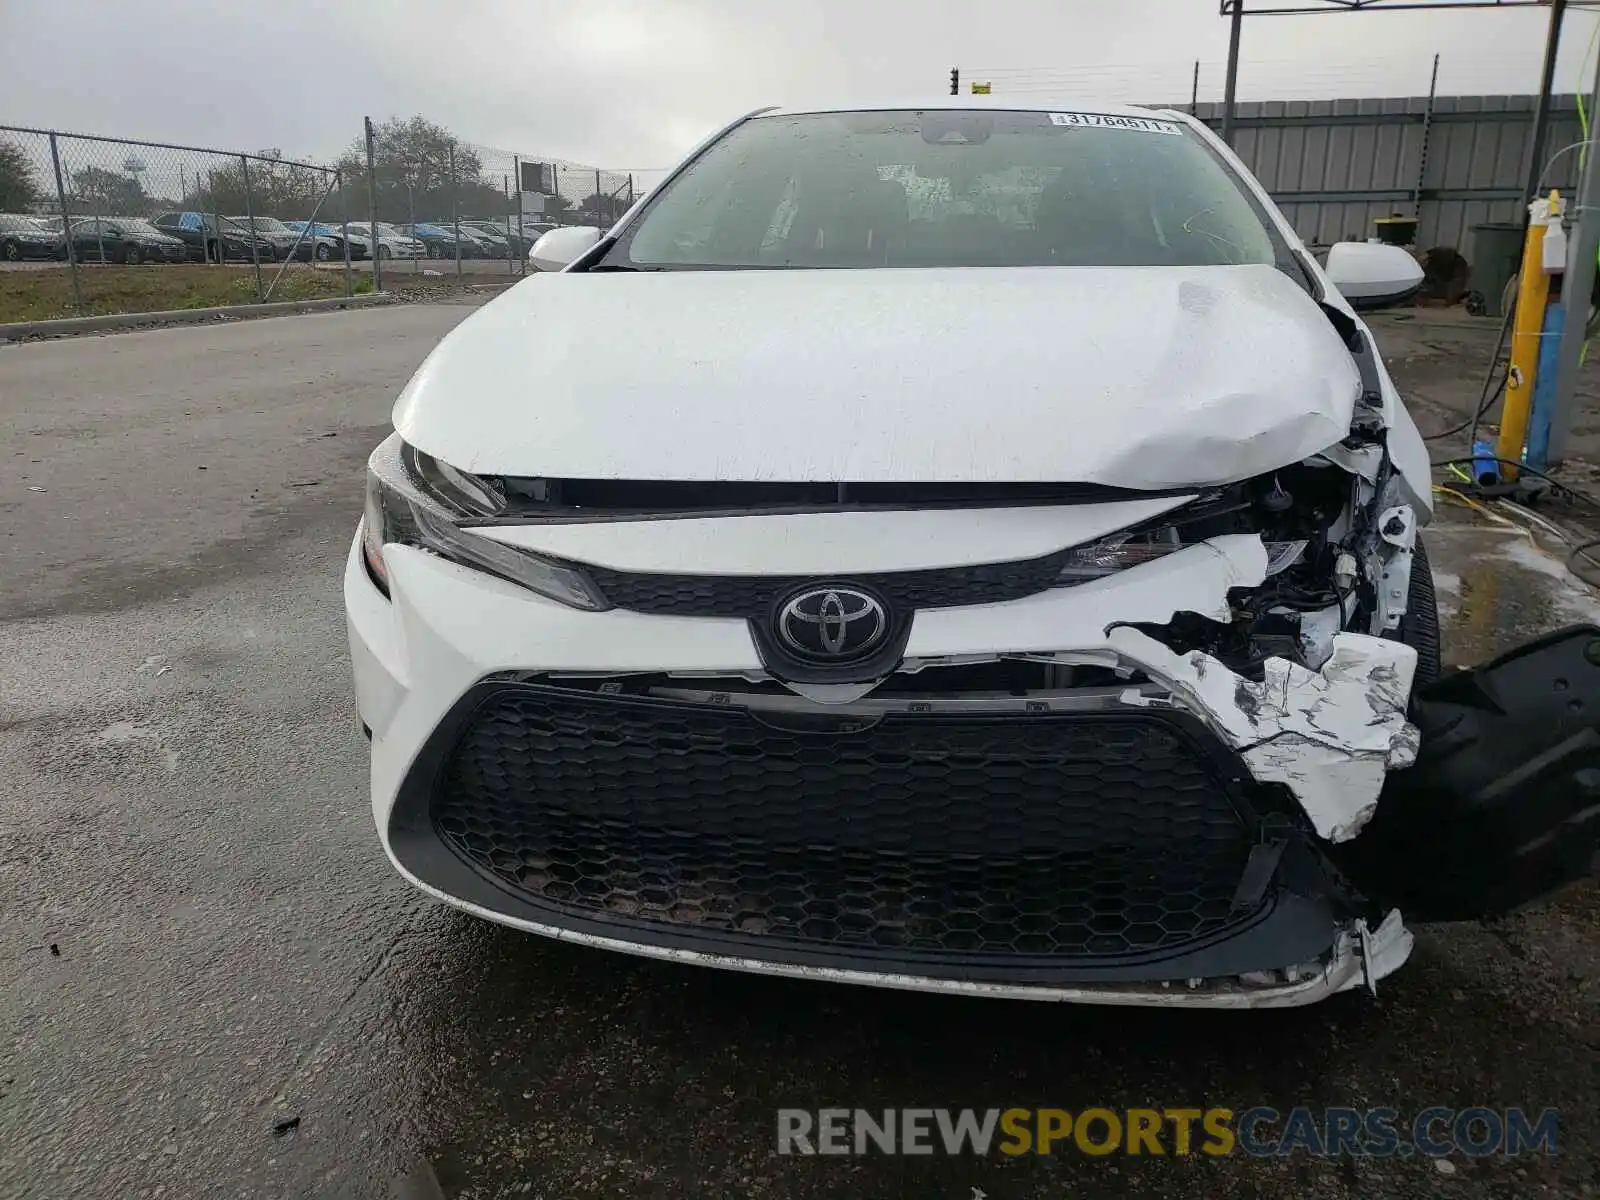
1184,96,1582,258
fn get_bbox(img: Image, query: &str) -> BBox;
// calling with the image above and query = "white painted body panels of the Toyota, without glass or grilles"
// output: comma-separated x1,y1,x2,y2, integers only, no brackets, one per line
346,98,1472,1006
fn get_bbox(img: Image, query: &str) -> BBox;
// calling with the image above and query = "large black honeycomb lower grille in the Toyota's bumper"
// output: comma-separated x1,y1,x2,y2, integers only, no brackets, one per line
429,685,1251,958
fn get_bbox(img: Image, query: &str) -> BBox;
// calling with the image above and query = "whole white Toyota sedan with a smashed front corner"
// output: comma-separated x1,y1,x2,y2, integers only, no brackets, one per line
344,98,1600,1006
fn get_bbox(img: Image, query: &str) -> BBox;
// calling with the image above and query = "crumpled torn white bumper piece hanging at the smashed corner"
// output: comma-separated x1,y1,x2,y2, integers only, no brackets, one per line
1110,627,1418,842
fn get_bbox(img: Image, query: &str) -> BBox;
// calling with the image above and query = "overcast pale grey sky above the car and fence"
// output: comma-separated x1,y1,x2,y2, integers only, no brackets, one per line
0,0,1600,170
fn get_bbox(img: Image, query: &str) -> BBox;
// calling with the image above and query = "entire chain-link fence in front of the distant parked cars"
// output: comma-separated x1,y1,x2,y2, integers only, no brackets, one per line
0,117,649,318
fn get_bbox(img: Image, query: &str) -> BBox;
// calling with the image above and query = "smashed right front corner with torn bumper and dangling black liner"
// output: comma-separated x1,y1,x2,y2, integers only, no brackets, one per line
1083,329,1600,990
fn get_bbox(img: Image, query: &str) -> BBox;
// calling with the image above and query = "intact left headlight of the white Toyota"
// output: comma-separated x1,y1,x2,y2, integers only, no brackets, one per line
362,434,606,611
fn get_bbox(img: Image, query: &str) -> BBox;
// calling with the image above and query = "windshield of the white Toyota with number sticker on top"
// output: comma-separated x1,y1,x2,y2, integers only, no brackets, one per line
606,110,1278,269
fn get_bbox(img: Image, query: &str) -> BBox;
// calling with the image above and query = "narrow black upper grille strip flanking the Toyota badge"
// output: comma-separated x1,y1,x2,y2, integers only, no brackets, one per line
582,547,1072,618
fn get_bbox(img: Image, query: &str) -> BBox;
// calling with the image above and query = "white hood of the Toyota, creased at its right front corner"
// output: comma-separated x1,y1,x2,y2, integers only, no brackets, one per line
394,266,1360,490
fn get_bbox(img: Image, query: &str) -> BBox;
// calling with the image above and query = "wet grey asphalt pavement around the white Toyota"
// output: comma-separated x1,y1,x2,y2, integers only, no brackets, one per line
0,306,1600,1200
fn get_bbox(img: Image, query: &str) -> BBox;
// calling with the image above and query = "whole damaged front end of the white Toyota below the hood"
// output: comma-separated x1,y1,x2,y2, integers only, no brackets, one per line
363,316,1600,1008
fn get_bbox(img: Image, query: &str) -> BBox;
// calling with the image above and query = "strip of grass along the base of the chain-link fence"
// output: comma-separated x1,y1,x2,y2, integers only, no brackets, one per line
0,262,377,323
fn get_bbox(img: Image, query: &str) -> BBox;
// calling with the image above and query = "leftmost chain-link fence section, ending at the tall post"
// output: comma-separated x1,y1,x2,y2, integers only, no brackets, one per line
0,126,356,312
